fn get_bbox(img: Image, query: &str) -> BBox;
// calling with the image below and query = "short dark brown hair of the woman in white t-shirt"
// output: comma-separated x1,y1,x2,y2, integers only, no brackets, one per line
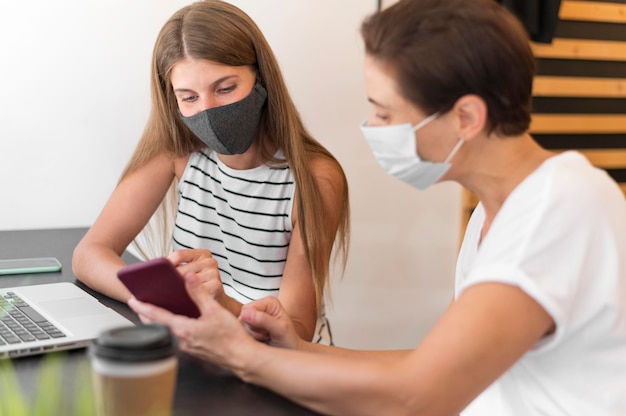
361,0,535,136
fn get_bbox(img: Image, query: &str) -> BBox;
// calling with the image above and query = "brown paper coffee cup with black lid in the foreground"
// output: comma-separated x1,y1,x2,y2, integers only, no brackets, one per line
89,325,178,416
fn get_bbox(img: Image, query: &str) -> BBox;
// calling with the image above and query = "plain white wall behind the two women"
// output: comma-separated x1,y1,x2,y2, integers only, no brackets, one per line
0,0,460,348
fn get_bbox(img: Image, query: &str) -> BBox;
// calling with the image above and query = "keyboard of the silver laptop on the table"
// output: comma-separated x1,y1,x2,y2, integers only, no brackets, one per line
0,292,65,345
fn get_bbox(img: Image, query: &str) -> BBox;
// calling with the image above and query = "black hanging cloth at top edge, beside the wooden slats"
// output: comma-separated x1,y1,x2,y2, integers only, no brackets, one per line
496,0,561,43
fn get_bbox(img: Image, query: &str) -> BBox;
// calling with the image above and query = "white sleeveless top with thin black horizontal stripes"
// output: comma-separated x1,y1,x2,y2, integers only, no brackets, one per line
173,149,295,303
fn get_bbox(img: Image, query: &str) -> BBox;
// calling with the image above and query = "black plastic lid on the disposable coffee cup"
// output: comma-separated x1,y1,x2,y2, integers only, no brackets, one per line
89,324,174,362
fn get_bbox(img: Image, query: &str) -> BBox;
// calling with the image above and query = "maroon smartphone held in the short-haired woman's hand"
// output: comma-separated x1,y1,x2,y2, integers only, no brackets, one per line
117,257,200,318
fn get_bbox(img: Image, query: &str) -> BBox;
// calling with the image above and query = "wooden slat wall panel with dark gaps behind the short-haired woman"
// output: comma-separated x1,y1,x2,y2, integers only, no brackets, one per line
461,0,626,242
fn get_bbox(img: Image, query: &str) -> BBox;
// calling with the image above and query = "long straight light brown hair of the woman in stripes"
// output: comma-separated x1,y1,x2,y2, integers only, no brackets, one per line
122,0,350,305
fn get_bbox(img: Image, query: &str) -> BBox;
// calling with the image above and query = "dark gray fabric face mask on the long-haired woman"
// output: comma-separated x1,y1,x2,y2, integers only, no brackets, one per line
178,82,267,155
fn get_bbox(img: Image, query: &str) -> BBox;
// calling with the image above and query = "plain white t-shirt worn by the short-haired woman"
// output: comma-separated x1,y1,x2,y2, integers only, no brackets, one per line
455,151,626,416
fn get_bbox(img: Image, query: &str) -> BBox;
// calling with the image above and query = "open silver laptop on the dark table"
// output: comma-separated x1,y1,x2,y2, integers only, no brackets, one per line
0,282,135,359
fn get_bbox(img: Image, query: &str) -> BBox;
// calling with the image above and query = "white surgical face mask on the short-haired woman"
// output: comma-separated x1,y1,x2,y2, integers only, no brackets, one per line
361,113,463,190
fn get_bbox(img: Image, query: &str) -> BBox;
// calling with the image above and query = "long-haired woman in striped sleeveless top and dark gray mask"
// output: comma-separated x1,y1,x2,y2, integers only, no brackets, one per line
73,0,349,343
